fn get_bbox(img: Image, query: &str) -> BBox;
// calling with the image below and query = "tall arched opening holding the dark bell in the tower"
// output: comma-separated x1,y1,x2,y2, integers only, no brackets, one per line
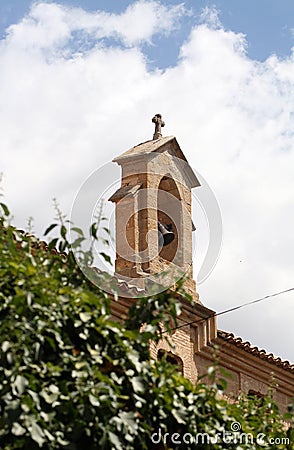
157,175,182,263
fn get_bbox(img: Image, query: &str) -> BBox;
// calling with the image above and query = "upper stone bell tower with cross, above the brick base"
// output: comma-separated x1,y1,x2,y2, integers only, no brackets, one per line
109,114,200,300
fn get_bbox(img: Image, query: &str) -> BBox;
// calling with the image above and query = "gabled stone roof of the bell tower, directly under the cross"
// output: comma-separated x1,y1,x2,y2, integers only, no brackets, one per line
113,136,200,188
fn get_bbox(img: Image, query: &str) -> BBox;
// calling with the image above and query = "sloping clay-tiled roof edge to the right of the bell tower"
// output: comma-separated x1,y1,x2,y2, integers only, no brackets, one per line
217,330,294,373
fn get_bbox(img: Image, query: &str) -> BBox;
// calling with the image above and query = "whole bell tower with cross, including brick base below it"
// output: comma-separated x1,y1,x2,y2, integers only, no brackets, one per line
109,114,216,382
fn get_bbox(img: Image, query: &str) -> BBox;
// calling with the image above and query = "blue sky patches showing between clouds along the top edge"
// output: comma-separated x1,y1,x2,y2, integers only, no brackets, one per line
0,0,294,68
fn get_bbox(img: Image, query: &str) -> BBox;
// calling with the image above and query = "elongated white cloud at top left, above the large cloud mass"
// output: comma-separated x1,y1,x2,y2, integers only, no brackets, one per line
4,0,186,50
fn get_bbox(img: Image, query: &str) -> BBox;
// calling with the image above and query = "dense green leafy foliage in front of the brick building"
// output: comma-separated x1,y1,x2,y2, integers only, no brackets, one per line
0,203,293,450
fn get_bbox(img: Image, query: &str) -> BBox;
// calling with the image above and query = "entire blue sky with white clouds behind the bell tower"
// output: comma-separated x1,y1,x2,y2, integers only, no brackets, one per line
0,0,294,362
